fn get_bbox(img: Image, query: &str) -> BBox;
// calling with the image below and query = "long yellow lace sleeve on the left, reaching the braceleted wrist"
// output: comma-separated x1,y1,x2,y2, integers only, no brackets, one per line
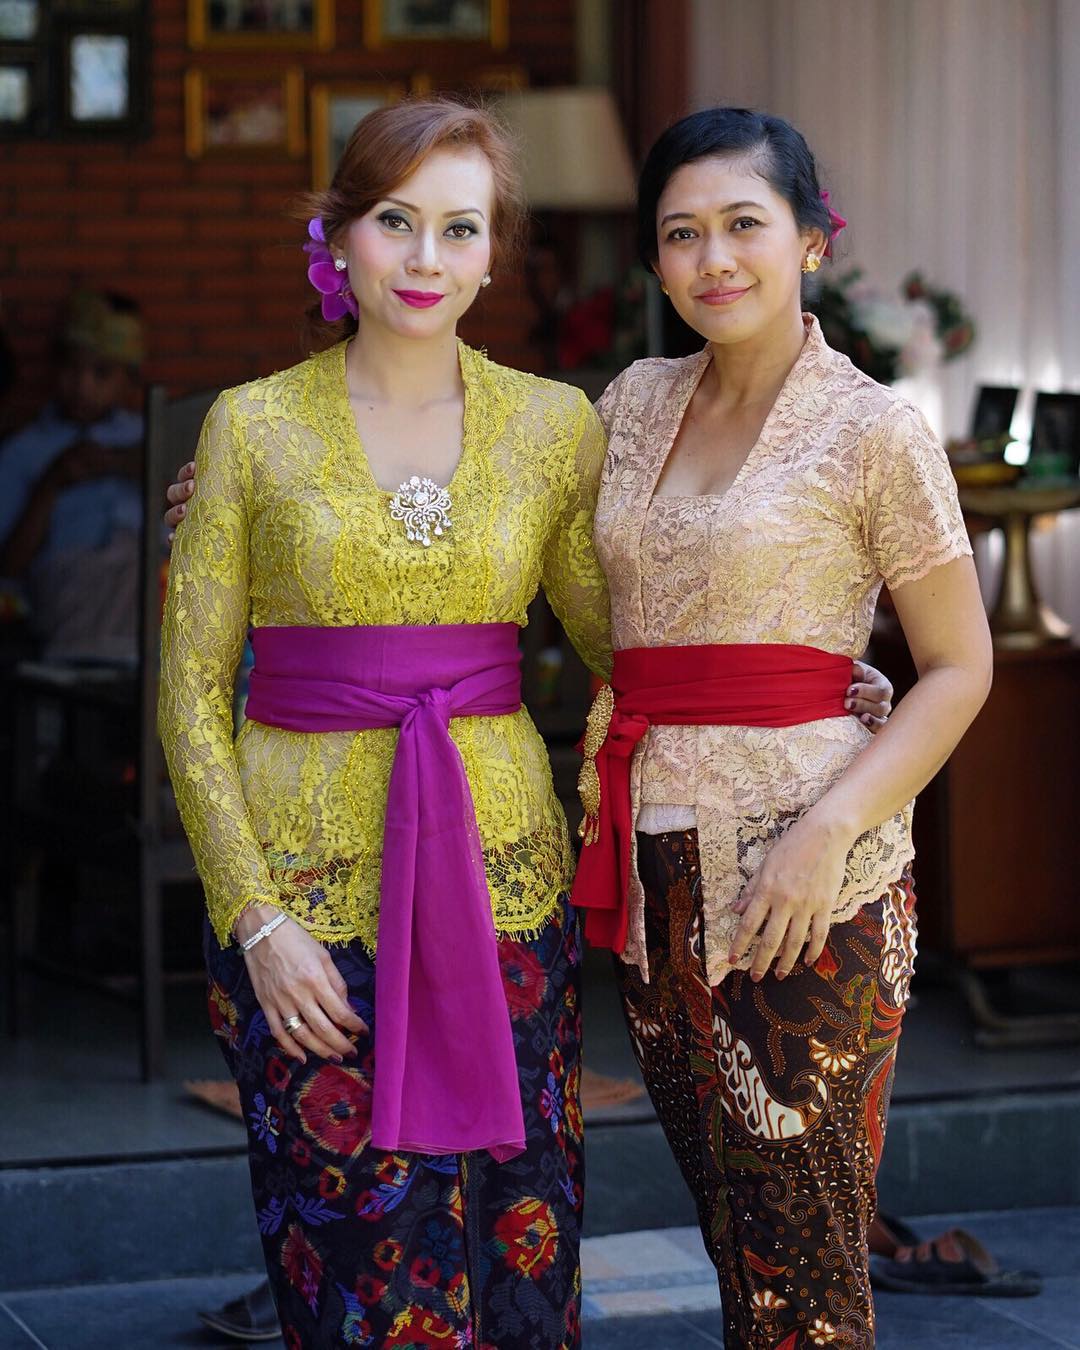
158,394,278,944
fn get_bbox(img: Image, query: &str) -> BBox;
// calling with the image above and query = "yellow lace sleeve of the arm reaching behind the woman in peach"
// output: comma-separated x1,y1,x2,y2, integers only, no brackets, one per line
541,394,612,679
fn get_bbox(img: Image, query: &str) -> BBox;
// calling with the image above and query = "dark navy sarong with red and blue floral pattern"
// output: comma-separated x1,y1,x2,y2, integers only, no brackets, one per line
207,905,585,1350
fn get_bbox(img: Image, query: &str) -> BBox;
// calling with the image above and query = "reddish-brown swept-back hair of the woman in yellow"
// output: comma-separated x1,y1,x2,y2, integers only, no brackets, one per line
298,96,527,351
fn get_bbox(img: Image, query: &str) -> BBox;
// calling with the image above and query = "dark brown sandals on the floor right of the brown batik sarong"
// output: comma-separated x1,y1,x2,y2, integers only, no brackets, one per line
869,1220,1042,1299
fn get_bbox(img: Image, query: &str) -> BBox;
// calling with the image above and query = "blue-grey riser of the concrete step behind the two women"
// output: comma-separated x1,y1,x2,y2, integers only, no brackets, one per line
0,1091,1080,1289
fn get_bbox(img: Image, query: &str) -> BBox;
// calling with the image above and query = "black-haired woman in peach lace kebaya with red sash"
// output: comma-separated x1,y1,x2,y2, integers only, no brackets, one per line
574,108,991,1350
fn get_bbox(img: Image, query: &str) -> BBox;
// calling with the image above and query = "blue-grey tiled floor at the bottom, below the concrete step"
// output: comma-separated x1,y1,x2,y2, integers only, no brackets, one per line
0,1208,1080,1350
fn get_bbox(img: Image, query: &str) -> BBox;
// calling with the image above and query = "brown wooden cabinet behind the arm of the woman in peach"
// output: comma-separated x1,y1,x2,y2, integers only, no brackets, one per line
873,633,1080,968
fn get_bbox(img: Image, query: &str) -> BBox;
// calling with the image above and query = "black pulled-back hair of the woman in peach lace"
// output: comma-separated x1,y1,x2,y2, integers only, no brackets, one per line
637,108,833,267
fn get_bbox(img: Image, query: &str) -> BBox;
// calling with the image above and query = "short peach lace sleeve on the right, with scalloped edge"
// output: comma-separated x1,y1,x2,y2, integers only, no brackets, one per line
863,401,972,589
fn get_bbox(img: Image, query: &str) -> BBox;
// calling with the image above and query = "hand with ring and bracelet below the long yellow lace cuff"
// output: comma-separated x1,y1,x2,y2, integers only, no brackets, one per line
235,905,367,1062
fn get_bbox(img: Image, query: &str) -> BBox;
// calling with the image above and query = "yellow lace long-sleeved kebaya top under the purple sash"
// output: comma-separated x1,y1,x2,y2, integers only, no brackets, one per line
158,343,610,952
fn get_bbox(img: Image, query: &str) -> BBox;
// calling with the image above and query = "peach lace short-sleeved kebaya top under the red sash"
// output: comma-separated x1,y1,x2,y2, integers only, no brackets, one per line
595,316,971,984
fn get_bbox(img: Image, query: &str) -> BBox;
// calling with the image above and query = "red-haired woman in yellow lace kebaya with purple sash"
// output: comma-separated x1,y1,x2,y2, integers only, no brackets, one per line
159,100,610,1350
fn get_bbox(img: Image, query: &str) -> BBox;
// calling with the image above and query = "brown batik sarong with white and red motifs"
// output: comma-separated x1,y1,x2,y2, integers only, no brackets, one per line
616,830,915,1350
